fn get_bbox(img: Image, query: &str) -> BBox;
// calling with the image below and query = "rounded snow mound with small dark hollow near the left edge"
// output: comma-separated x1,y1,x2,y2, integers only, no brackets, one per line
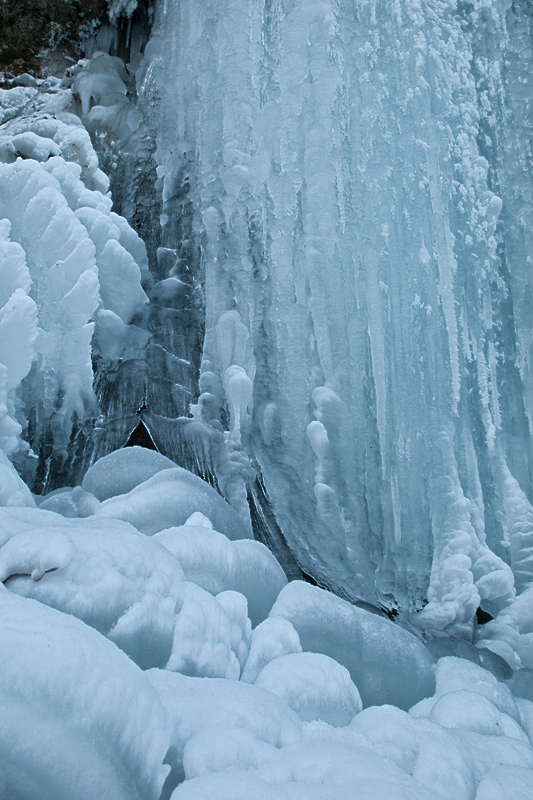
0,509,184,634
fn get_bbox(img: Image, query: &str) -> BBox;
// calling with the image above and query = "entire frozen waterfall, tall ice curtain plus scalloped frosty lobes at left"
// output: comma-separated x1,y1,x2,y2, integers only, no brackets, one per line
0,0,533,640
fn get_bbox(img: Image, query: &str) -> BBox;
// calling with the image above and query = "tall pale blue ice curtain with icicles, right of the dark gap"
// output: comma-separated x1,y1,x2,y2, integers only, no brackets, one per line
138,0,533,632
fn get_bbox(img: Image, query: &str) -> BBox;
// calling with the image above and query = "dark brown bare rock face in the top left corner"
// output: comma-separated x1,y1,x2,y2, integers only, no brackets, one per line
0,0,107,75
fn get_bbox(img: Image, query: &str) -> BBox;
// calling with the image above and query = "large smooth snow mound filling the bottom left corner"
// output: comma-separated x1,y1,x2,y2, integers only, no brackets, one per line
0,587,169,800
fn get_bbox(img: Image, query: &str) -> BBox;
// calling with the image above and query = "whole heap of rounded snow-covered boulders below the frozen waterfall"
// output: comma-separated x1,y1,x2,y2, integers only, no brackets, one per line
0,448,533,800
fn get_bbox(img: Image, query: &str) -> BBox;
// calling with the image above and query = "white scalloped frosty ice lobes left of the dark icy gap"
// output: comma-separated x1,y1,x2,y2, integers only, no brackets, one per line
0,82,147,485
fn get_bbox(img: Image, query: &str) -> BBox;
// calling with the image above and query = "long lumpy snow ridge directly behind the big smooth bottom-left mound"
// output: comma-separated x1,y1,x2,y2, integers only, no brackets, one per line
0,506,251,680
